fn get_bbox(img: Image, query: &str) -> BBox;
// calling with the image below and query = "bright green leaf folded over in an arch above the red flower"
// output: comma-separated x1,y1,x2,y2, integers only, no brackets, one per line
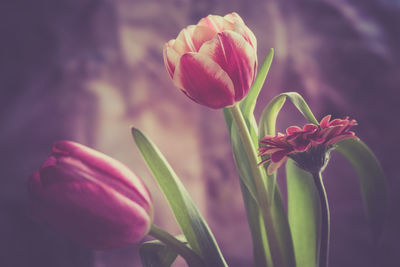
258,92,319,139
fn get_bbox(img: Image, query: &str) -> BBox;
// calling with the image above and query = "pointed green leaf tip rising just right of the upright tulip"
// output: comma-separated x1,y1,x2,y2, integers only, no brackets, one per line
240,48,274,117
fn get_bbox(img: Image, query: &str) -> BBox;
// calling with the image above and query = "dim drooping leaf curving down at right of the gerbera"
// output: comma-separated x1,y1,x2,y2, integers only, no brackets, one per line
336,139,387,242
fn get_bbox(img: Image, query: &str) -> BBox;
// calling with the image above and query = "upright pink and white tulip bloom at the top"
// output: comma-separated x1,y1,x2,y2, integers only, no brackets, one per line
163,13,257,109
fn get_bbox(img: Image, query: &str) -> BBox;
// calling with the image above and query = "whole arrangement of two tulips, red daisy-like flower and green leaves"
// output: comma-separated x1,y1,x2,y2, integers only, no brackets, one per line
28,13,386,267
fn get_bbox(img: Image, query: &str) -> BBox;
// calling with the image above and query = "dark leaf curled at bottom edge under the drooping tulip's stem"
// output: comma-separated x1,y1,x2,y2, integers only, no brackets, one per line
139,240,178,267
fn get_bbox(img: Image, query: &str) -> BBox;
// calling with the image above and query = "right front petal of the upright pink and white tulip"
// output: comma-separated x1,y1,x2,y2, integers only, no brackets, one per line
199,31,256,101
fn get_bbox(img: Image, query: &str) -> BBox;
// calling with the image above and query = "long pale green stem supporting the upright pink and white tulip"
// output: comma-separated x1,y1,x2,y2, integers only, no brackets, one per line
229,105,286,267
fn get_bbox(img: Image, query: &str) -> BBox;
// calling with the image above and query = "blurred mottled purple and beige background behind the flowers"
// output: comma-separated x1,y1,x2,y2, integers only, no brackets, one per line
0,0,400,267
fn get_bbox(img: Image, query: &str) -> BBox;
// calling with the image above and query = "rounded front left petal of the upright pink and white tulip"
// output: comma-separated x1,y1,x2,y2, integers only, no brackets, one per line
174,53,235,109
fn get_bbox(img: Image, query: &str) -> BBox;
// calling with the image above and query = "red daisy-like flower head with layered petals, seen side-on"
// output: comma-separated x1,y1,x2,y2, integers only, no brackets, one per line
259,115,357,174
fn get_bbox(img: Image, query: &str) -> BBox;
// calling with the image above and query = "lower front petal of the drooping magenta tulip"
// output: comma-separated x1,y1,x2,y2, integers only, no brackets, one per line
33,180,151,249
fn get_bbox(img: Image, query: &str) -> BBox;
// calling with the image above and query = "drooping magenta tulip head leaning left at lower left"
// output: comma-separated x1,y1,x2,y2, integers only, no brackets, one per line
28,141,153,249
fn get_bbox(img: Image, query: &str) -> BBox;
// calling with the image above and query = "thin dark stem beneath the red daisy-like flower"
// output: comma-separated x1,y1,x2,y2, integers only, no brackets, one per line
313,172,330,267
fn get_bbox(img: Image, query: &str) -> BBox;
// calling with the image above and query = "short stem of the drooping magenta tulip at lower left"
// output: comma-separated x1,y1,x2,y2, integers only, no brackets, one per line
149,224,204,267
